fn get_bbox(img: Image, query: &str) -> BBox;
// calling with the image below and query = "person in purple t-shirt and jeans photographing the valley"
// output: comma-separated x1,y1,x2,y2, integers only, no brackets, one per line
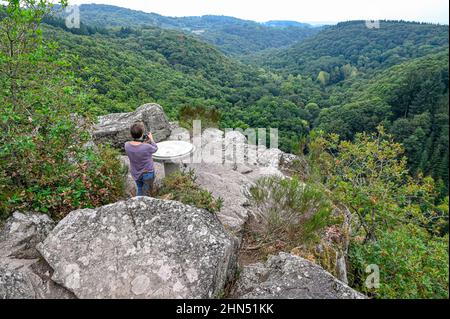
125,122,158,196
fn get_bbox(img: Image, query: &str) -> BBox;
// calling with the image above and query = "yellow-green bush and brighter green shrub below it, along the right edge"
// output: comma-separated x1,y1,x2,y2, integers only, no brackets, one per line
309,127,449,298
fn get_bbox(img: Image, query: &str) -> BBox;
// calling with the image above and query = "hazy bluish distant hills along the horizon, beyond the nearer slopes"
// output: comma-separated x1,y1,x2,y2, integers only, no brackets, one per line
73,4,320,55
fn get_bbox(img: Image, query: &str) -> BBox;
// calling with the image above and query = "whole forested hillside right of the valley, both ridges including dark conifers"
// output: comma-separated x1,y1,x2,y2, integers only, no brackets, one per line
248,21,449,189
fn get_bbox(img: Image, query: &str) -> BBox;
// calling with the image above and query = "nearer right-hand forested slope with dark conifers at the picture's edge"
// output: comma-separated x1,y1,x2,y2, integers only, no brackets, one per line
316,49,449,189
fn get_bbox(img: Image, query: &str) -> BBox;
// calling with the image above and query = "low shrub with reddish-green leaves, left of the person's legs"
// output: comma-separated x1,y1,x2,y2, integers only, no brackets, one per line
0,147,124,219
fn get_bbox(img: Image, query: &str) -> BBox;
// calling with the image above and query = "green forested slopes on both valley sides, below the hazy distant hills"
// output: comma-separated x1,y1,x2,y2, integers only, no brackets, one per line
40,15,448,189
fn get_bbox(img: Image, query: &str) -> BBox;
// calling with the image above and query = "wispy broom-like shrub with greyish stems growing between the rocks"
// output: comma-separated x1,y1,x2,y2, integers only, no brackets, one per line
246,176,335,247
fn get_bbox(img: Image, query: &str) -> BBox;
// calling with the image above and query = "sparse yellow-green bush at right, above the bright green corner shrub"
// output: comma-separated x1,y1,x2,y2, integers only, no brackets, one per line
311,126,446,241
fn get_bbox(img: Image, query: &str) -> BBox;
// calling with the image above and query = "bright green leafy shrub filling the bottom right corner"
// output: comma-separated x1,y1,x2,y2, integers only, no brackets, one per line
349,224,449,299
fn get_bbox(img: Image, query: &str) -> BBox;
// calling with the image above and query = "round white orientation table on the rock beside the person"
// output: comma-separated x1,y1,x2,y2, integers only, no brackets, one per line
153,141,195,176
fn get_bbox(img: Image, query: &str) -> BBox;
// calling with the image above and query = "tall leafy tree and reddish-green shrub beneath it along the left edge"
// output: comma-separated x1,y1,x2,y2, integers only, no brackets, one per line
0,0,123,219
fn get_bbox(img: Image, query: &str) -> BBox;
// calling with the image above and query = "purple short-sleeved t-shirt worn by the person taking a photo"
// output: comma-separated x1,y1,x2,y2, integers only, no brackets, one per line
125,142,158,181
